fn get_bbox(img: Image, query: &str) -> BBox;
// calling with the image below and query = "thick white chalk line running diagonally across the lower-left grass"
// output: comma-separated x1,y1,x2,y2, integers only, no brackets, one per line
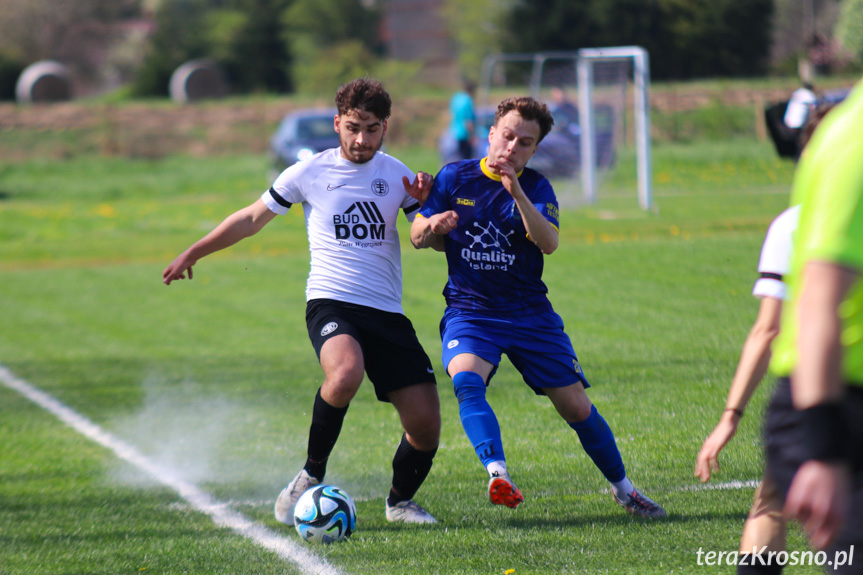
0,364,341,575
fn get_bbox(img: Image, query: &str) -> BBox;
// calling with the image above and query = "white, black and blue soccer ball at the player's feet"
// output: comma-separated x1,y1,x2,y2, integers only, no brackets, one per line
294,485,357,544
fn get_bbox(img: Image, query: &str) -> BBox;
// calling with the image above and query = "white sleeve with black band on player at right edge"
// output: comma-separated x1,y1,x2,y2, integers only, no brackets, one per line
752,206,800,300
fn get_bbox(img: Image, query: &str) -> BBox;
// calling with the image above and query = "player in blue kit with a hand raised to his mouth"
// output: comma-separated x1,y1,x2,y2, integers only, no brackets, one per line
411,94,666,517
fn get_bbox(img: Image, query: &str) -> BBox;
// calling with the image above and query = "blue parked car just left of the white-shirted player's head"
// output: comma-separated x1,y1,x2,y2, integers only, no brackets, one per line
270,108,339,175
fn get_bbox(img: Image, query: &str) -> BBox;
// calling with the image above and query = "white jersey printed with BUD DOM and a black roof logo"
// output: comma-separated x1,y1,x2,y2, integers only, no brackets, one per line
262,148,420,313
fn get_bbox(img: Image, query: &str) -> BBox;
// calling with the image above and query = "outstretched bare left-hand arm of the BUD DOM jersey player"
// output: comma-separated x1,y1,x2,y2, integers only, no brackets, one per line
162,199,276,285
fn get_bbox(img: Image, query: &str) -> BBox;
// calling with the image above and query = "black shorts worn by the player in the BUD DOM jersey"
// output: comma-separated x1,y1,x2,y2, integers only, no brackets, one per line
306,299,437,401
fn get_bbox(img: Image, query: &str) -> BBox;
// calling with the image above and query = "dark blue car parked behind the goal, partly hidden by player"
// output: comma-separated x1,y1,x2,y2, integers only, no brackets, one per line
438,105,615,178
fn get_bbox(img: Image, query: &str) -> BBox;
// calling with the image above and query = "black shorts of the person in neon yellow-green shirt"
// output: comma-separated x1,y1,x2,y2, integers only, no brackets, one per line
764,377,863,573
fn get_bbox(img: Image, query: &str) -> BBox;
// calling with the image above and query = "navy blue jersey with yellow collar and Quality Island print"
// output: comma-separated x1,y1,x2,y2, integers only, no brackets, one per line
420,158,558,312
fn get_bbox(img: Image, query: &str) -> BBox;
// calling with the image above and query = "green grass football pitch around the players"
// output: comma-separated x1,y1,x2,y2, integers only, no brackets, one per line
0,140,832,575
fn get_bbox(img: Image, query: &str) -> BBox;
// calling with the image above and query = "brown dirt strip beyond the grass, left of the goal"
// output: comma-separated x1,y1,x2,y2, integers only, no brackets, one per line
0,96,446,159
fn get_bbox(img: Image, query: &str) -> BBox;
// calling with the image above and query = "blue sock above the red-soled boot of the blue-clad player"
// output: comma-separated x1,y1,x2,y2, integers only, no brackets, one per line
452,371,505,466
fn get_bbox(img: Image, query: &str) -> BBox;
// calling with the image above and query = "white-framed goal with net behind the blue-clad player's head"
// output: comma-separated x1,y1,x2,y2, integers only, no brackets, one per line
477,47,653,210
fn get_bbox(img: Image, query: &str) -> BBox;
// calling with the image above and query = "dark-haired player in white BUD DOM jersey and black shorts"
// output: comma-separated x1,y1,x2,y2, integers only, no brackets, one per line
163,78,441,525
